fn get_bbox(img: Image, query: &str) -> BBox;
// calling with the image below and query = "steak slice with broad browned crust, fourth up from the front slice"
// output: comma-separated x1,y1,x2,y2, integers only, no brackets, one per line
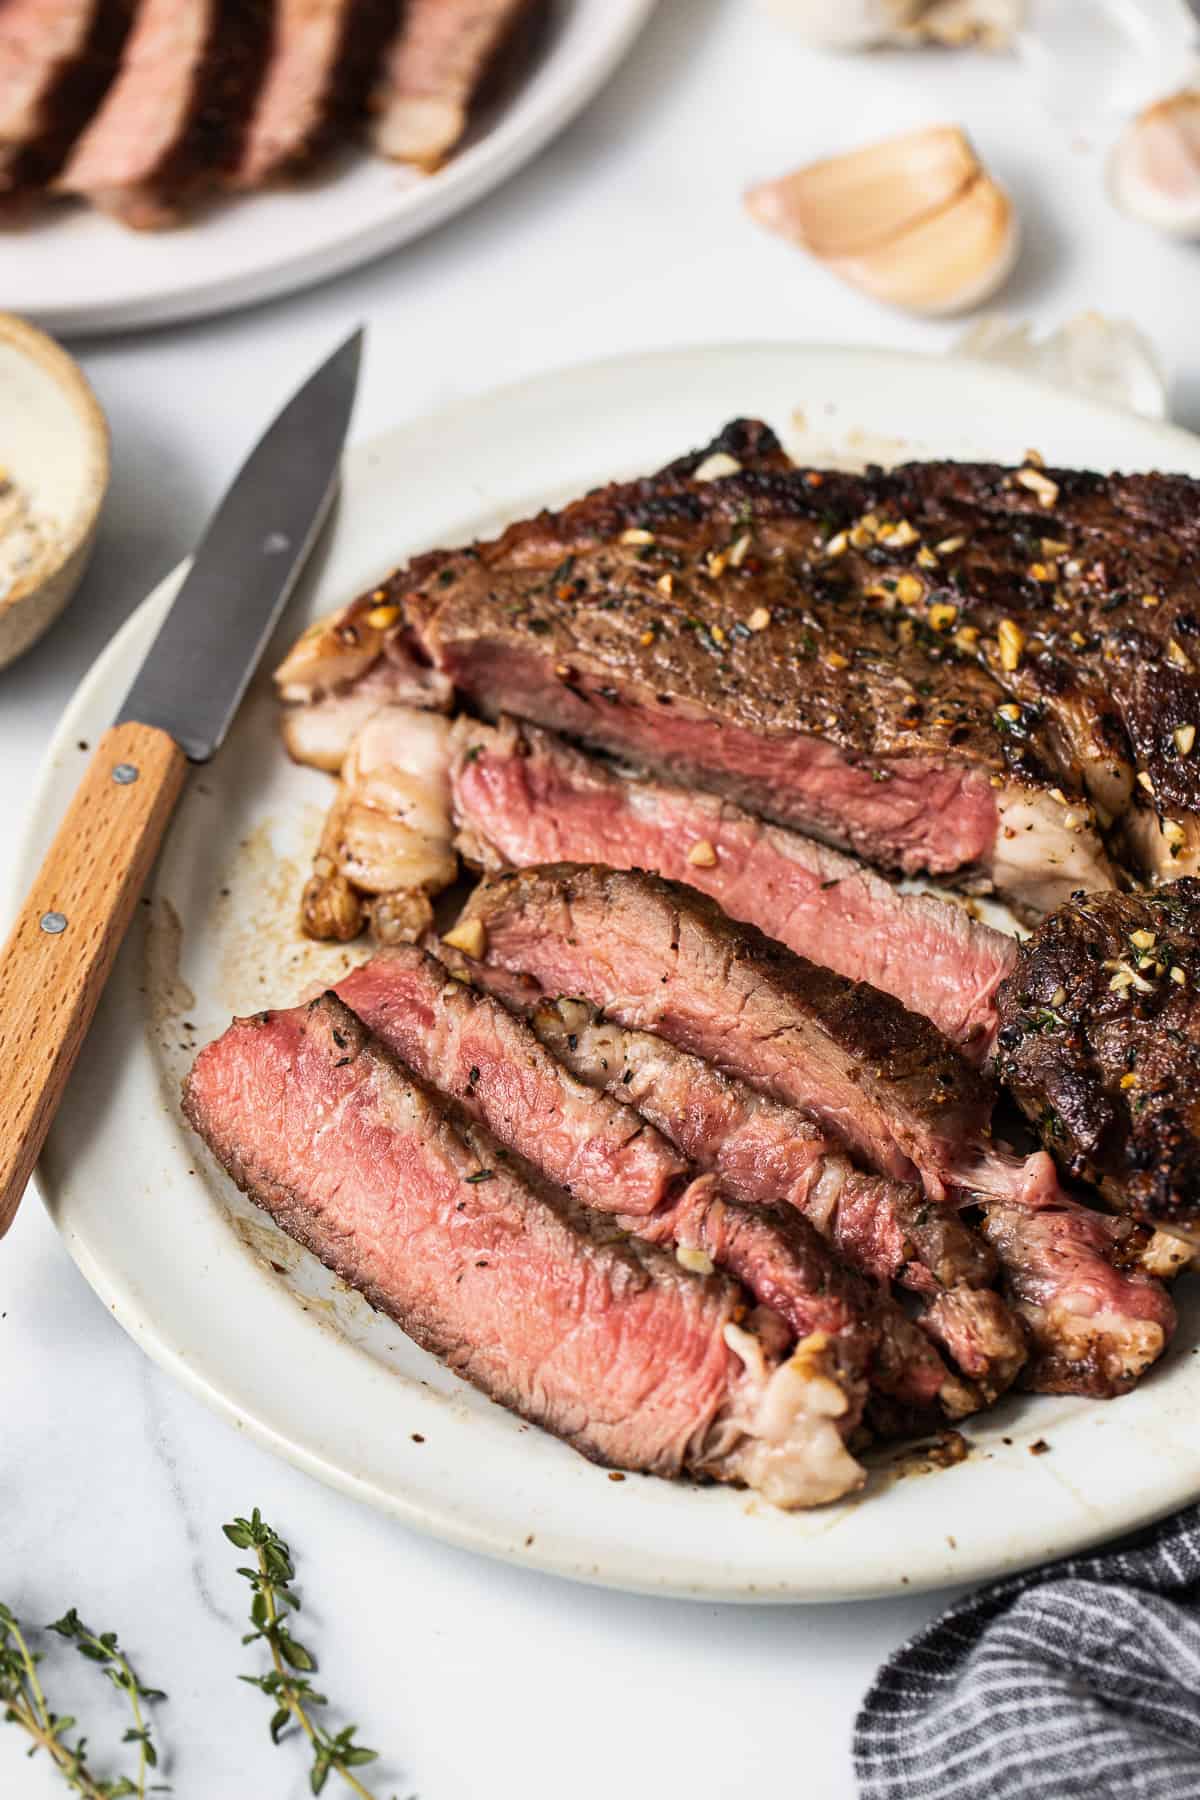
455,864,993,1202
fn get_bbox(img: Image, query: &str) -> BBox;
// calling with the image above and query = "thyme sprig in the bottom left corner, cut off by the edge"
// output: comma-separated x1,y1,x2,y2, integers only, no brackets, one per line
0,1604,167,1800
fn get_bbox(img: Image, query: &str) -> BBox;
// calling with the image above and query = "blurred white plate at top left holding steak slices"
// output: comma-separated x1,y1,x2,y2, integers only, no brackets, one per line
4,0,655,333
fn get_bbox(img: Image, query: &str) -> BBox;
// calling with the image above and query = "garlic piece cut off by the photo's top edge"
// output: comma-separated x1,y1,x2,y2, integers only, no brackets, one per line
761,0,1025,50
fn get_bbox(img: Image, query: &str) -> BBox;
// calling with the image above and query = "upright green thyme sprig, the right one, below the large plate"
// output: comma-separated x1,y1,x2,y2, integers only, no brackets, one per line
221,1507,380,1800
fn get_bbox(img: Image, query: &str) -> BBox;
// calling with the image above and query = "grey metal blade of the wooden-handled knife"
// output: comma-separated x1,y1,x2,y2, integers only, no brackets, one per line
117,329,363,763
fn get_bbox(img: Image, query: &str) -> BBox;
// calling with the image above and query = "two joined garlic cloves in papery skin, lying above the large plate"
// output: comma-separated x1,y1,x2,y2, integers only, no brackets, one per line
747,126,1020,317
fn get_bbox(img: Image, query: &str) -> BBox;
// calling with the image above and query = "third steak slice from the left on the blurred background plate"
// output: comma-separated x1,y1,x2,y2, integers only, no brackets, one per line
230,0,396,187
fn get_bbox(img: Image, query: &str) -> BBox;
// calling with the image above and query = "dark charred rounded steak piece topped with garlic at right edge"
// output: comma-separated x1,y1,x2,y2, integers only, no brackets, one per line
997,877,1200,1237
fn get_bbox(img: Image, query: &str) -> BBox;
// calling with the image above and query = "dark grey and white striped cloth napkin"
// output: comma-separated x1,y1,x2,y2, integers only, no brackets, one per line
855,1507,1200,1800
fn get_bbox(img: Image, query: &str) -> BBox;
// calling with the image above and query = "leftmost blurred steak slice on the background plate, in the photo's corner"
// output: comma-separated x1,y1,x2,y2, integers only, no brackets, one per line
0,0,133,203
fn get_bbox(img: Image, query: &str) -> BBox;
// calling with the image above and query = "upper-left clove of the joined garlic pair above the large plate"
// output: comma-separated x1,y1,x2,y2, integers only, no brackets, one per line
747,126,979,257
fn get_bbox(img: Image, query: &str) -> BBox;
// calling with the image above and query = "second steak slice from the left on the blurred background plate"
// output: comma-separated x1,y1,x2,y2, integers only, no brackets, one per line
56,0,273,229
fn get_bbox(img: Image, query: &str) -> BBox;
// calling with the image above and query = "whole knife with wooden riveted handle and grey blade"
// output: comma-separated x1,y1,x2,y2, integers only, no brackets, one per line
0,331,363,1235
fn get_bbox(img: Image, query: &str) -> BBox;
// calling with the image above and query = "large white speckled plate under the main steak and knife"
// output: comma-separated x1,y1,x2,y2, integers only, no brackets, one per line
22,347,1200,1600
